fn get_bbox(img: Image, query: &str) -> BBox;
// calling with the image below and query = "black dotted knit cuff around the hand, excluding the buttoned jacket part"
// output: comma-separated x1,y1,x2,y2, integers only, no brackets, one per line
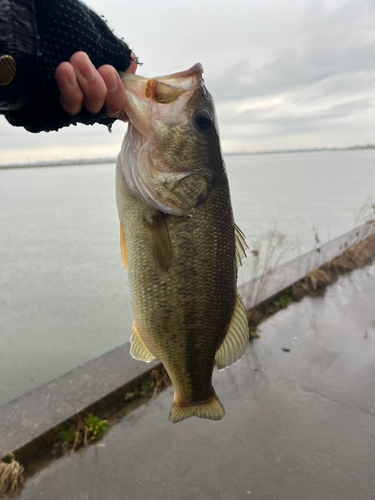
1,0,131,132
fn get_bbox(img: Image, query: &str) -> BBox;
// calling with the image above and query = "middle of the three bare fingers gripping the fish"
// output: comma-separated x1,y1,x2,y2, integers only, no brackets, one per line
70,52,107,114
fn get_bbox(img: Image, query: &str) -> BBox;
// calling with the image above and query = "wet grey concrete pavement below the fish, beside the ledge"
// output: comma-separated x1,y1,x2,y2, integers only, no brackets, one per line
21,265,375,500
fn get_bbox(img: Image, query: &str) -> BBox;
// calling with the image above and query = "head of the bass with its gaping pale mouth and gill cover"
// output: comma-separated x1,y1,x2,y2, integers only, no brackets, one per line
120,64,223,215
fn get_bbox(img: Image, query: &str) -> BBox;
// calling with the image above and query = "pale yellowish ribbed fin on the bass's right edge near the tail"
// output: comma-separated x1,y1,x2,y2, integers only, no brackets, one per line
215,292,249,370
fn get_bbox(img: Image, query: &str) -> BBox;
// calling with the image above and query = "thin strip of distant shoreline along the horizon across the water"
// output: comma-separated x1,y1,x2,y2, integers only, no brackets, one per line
0,144,375,170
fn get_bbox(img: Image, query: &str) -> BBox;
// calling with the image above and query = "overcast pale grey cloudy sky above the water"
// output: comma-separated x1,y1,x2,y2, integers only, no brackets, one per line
0,0,375,164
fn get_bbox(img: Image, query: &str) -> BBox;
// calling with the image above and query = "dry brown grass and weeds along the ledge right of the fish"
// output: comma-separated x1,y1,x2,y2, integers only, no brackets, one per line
243,218,375,332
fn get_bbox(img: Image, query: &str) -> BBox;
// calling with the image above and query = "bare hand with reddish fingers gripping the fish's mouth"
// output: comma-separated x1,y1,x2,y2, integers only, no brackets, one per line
55,52,137,121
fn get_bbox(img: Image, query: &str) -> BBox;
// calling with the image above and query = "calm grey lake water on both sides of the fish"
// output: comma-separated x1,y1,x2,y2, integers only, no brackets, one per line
0,150,375,405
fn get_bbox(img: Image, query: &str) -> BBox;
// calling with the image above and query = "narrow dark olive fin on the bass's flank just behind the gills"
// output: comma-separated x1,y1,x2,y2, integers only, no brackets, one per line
144,210,172,276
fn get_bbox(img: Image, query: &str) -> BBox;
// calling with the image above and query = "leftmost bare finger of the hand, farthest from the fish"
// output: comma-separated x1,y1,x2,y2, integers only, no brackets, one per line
55,62,84,116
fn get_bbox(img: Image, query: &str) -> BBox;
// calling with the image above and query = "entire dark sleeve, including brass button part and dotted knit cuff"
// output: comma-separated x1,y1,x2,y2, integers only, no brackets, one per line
0,0,131,132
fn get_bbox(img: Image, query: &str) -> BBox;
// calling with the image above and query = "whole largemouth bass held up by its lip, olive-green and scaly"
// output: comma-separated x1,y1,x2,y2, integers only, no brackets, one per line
116,64,249,422
